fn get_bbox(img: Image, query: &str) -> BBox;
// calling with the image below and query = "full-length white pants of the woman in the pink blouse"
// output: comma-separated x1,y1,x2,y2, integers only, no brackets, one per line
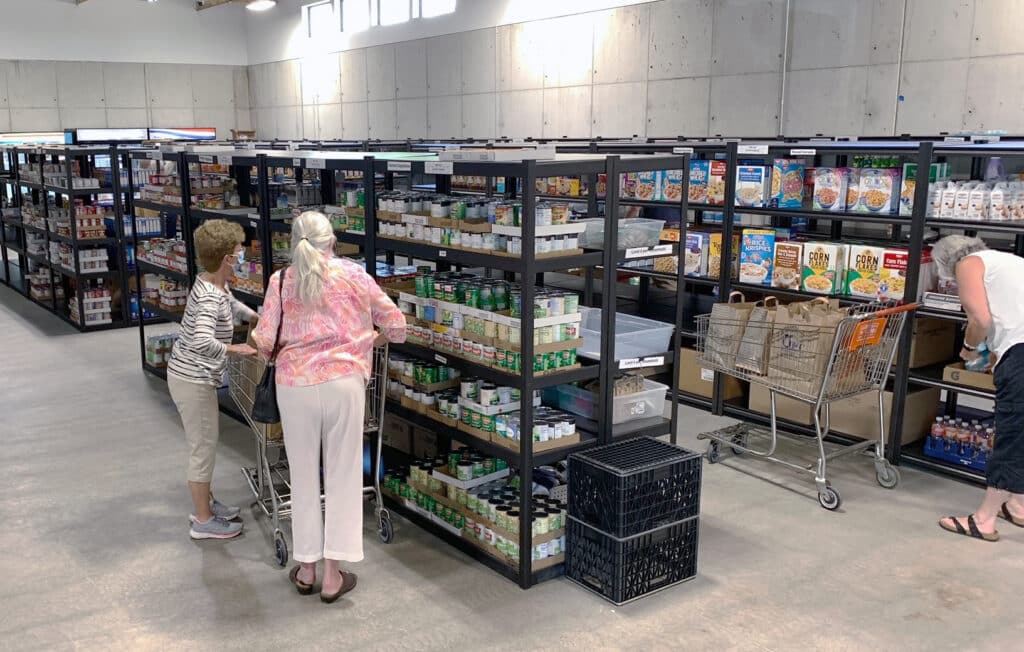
278,376,367,563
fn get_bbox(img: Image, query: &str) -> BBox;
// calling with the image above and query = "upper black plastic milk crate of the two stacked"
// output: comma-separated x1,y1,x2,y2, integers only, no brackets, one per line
568,437,702,537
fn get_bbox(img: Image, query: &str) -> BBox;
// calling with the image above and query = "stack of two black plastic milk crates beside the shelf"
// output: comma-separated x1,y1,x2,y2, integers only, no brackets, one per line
565,437,701,605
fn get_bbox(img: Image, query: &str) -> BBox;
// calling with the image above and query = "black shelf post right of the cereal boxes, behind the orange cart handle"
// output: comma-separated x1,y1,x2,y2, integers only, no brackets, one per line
892,140,932,463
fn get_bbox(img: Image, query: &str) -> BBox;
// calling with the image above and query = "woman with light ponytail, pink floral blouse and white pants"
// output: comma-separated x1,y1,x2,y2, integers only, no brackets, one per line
253,212,406,603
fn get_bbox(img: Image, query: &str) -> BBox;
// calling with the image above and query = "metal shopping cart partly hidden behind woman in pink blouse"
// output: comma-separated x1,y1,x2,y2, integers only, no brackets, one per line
227,344,394,566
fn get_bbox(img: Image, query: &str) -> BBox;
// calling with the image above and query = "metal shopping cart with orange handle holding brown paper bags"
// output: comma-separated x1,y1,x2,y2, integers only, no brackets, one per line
697,303,916,510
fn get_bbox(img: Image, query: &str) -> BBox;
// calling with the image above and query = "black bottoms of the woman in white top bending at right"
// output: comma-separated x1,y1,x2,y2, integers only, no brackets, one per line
985,344,1024,493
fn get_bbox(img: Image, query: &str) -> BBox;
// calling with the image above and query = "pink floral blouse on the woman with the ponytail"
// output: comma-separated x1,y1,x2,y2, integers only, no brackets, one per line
253,253,406,387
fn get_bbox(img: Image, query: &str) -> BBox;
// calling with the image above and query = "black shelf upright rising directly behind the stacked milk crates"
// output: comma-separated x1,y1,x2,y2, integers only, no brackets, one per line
597,156,620,444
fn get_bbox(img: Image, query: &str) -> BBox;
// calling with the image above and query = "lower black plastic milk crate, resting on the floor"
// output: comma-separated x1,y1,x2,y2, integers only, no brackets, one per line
565,516,700,605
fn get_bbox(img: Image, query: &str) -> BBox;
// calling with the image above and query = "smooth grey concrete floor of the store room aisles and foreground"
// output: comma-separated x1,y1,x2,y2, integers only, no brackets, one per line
0,288,1024,650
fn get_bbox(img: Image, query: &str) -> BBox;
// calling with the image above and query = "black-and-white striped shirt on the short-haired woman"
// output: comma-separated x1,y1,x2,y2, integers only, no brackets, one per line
167,277,256,387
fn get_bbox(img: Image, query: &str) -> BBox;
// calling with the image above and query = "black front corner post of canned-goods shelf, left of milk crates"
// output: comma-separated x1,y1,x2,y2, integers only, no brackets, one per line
519,159,537,589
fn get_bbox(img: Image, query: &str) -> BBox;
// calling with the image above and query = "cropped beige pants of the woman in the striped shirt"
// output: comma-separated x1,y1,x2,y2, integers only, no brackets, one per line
167,374,220,482
